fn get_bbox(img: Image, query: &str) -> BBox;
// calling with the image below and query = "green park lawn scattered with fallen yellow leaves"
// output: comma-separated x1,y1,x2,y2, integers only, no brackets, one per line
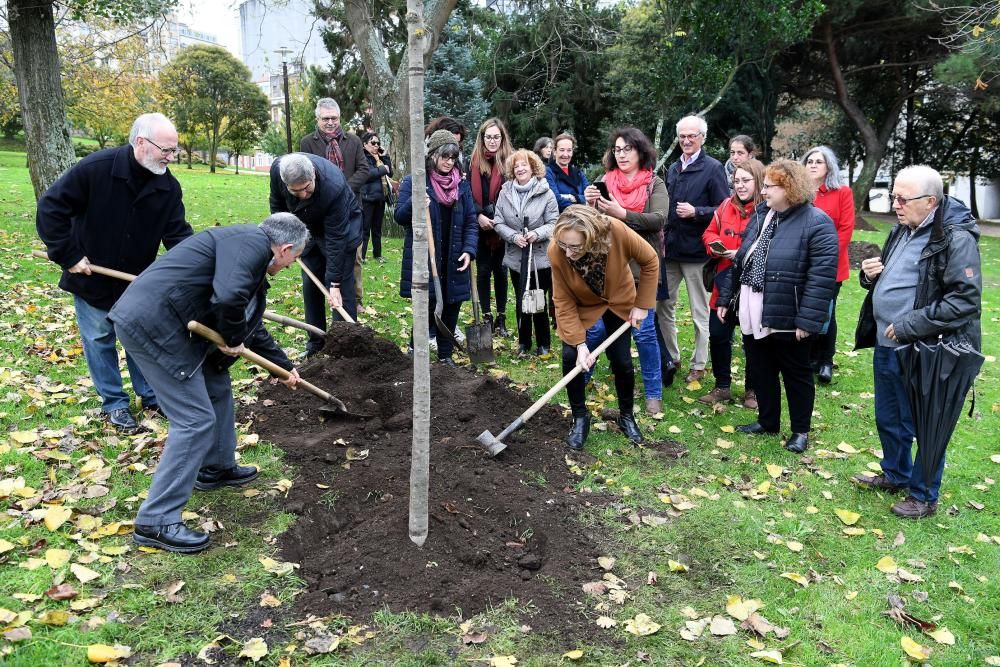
0,152,1000,667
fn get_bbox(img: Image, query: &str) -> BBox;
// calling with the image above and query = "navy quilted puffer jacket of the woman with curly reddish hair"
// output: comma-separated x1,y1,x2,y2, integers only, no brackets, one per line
716,203,837,334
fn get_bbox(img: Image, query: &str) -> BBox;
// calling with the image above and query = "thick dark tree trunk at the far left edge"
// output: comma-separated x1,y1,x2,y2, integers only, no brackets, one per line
7,0,76,199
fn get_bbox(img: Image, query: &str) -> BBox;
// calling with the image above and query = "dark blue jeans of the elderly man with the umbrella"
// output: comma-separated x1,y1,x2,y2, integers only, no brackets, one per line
874,345,944,503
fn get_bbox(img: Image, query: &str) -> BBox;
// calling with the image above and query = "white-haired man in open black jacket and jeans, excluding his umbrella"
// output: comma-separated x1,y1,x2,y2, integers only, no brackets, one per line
852,166,983,519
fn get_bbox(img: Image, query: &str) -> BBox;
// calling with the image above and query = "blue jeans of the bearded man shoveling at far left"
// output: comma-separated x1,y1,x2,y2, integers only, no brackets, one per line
73,296,156,412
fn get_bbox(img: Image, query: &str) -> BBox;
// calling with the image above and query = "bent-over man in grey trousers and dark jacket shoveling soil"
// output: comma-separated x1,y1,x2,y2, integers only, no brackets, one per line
108,213,309,553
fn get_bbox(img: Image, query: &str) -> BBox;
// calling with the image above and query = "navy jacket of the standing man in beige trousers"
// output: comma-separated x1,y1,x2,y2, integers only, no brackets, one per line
663,149,729,262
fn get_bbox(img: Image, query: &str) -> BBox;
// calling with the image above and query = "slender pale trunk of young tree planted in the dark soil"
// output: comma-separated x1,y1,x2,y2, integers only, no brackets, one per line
404,0,428,546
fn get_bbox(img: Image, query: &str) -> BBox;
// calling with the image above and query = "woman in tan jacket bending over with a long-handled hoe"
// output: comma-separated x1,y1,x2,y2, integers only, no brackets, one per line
548,205,659,450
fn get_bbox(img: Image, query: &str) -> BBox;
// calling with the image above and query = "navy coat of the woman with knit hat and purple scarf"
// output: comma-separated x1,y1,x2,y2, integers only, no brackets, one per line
393,176,479,303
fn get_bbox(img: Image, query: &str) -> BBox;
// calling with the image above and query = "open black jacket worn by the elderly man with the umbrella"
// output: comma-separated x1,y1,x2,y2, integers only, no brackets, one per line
854,195,983,350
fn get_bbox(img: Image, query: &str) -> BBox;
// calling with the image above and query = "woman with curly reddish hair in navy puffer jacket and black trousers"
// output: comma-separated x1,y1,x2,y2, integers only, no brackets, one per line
716,160,837,453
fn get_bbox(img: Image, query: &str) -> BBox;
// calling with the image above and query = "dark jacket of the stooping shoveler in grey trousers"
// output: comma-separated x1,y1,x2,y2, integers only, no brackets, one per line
108,225,293,380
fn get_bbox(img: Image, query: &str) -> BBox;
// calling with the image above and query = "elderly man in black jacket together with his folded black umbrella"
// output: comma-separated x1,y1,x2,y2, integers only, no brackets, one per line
852,166,982,519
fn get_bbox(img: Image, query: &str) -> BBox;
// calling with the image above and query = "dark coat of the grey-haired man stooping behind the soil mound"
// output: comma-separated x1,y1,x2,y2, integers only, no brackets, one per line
270,153,362,285
